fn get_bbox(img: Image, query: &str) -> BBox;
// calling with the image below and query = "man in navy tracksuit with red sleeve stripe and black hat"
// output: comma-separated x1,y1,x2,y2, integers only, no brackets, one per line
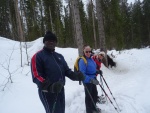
31,31,84,113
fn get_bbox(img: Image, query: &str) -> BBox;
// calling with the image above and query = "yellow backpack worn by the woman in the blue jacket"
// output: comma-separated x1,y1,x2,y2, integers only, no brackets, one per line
74,56,87,85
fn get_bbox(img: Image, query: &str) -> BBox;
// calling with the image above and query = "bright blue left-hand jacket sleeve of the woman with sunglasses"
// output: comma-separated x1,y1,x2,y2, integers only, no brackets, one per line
79,59,91,82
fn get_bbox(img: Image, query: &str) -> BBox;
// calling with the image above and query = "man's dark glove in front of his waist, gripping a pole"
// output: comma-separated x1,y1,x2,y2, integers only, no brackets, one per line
49,81,65,93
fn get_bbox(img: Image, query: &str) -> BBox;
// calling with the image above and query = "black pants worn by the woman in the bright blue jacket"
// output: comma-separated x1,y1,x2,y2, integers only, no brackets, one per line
84,83,98,113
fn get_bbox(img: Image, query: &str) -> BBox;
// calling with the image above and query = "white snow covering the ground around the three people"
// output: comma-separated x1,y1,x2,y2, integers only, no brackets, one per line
0,37,150,113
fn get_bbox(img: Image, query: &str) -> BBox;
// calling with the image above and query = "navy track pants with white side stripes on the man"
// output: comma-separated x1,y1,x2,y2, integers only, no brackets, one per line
38,89,65,113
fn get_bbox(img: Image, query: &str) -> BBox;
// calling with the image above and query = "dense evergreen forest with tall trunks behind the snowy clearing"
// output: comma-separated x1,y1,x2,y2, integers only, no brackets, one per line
0,0,150,50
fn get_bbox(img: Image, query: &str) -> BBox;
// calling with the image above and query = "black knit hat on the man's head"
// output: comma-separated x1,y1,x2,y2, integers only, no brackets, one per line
43,31,57,43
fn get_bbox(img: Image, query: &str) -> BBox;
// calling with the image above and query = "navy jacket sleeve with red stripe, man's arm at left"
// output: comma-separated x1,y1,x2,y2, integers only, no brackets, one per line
31,53,45,87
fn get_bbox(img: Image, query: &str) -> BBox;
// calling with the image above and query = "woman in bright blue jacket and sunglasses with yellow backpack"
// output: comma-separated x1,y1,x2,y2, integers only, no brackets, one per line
79,45,100,113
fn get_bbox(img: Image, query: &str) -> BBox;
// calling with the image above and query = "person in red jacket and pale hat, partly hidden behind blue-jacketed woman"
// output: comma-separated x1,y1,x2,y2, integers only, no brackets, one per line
92,51,105,103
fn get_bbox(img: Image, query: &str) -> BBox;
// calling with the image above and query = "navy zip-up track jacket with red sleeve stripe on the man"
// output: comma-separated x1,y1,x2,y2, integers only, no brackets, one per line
31,47,77,87
